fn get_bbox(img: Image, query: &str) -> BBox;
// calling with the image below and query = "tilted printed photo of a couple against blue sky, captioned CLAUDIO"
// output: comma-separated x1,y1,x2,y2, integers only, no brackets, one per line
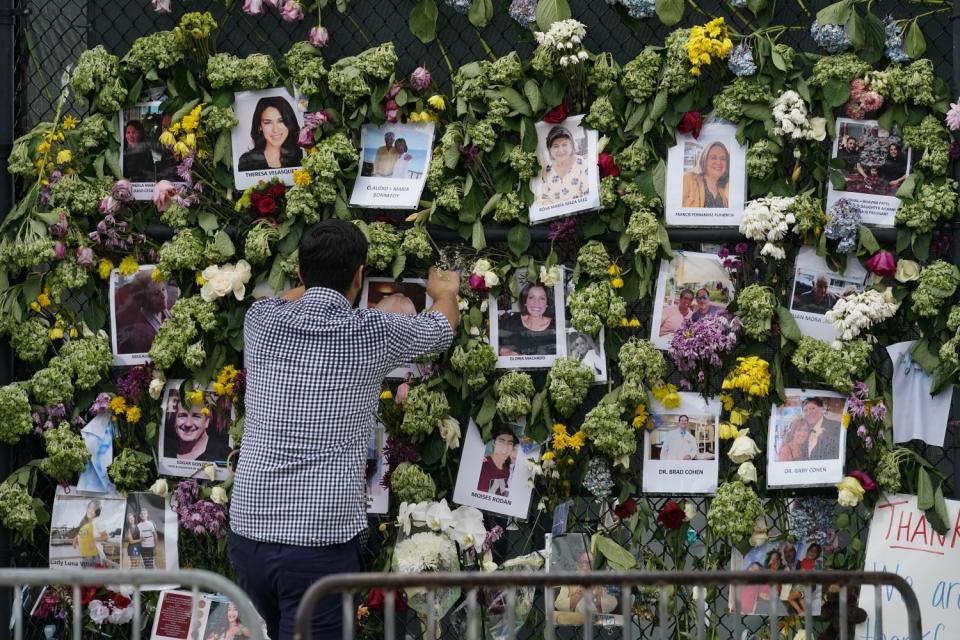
350,122,434,209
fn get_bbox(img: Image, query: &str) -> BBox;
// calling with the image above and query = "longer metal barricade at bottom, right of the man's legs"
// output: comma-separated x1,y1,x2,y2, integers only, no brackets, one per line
294,570,923,640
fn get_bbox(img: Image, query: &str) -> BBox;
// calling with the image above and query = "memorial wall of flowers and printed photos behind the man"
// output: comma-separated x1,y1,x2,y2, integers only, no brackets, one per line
0,0,960,626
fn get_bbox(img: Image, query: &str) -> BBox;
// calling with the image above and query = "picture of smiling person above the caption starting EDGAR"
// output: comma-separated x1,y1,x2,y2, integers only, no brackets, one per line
163,389,230,462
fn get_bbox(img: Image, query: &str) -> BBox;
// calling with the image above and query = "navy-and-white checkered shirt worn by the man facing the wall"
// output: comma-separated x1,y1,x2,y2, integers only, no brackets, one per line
230,287,453,546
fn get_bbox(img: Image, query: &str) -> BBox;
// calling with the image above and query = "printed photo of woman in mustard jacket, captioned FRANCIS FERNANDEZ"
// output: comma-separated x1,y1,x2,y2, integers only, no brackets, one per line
665,124,747,226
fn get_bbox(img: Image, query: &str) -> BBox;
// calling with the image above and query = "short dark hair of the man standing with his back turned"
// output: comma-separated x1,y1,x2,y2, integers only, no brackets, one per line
299,220,367,293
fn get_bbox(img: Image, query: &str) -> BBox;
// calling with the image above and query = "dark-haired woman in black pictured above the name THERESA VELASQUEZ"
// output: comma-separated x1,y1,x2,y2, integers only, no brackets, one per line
237,96,303,171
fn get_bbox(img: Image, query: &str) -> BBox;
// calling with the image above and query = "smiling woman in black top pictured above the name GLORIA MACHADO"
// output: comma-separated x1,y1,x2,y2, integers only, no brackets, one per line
498,282,557,356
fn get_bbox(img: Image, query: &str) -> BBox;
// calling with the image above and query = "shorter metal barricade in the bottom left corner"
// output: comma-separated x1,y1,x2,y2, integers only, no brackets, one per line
0,569,264,640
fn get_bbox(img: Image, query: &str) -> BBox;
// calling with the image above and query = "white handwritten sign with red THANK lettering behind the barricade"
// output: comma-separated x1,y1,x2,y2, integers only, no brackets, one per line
856,495,960,640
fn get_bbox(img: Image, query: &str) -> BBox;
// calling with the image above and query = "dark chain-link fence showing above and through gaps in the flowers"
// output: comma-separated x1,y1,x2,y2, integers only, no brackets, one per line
5,0,960,632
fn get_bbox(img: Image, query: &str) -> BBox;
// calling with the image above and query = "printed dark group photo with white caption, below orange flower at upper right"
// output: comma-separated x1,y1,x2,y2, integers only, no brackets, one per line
827,118,911,227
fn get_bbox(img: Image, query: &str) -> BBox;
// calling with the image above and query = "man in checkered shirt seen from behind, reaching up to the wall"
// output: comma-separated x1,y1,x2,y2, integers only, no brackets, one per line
229,220,460,640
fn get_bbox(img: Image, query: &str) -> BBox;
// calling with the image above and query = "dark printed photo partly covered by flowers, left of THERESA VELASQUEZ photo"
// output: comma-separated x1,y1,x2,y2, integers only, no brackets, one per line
120,100,182,200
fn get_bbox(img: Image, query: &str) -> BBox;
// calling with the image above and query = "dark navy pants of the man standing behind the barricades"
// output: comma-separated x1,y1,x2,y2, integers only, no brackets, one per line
229,531,361,640
